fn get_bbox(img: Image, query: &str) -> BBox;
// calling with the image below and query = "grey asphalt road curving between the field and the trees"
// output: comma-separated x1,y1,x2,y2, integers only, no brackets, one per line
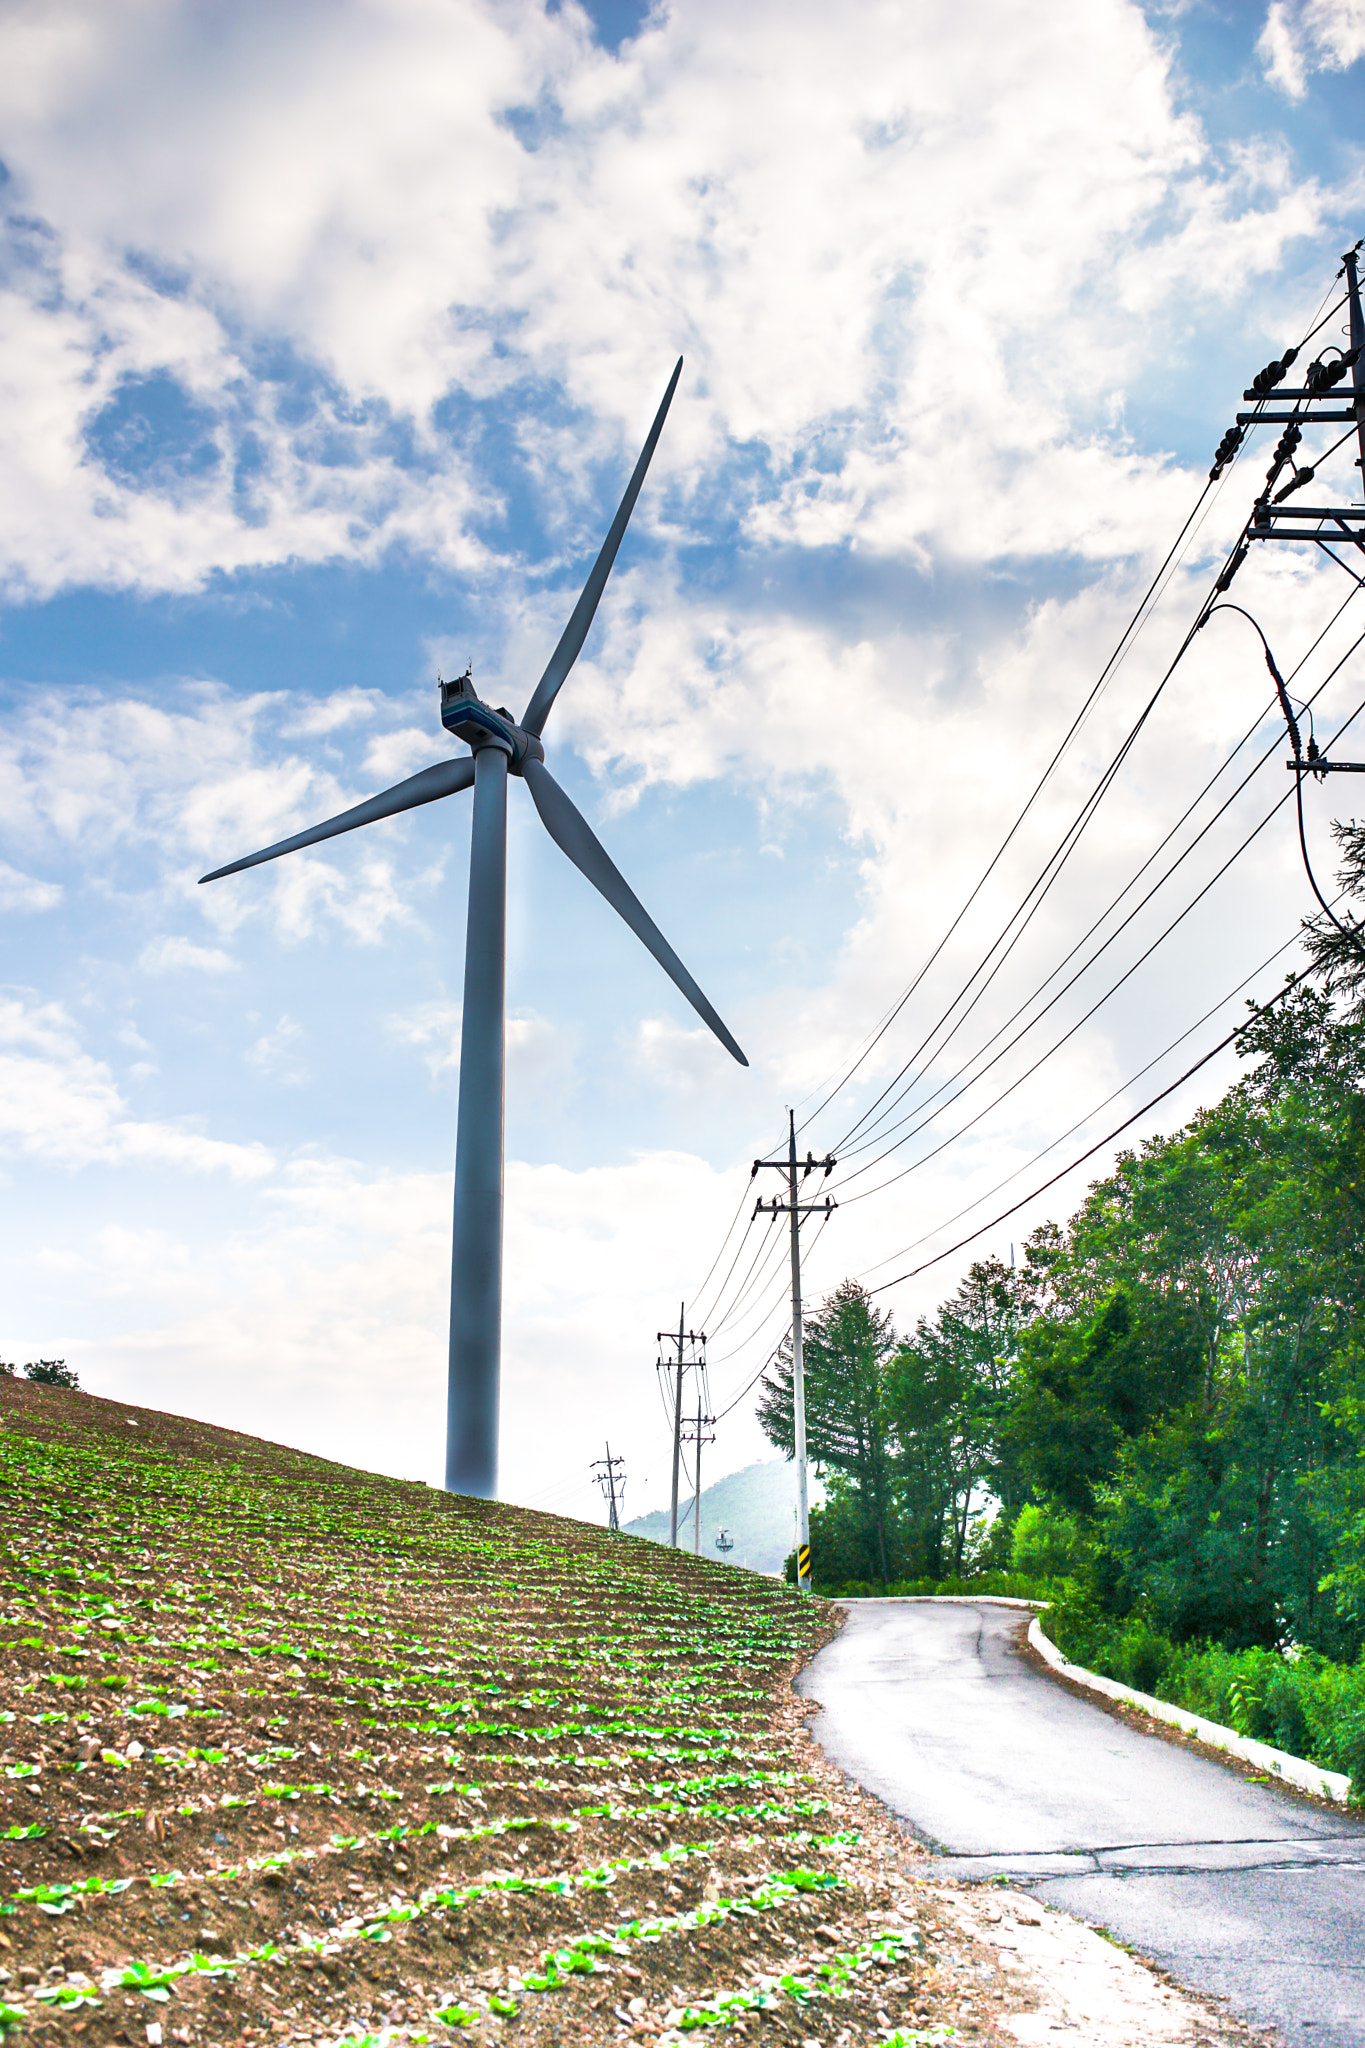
798,1599,1365,2048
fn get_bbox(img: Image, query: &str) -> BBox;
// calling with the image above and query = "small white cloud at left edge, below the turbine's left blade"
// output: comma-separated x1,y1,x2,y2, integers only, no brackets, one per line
0,995,274,1180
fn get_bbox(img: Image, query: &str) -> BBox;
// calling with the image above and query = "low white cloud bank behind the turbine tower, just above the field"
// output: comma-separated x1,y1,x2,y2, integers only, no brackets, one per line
10,1153,765,1511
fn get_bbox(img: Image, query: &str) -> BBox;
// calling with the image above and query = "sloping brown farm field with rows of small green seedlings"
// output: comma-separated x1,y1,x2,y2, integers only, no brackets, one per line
0,1378,1244,2048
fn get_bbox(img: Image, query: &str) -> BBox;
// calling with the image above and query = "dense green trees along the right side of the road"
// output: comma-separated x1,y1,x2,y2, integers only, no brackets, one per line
761,974,1365,1718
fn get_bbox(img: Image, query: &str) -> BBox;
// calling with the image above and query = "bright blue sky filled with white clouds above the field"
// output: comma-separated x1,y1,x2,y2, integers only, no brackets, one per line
0,0,1365,1540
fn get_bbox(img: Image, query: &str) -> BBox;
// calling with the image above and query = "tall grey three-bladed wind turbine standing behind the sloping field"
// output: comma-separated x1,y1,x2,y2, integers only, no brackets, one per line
201,356,749,1499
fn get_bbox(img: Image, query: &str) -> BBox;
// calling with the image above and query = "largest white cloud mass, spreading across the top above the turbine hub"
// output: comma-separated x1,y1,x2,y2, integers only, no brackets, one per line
0,0,1334,606
